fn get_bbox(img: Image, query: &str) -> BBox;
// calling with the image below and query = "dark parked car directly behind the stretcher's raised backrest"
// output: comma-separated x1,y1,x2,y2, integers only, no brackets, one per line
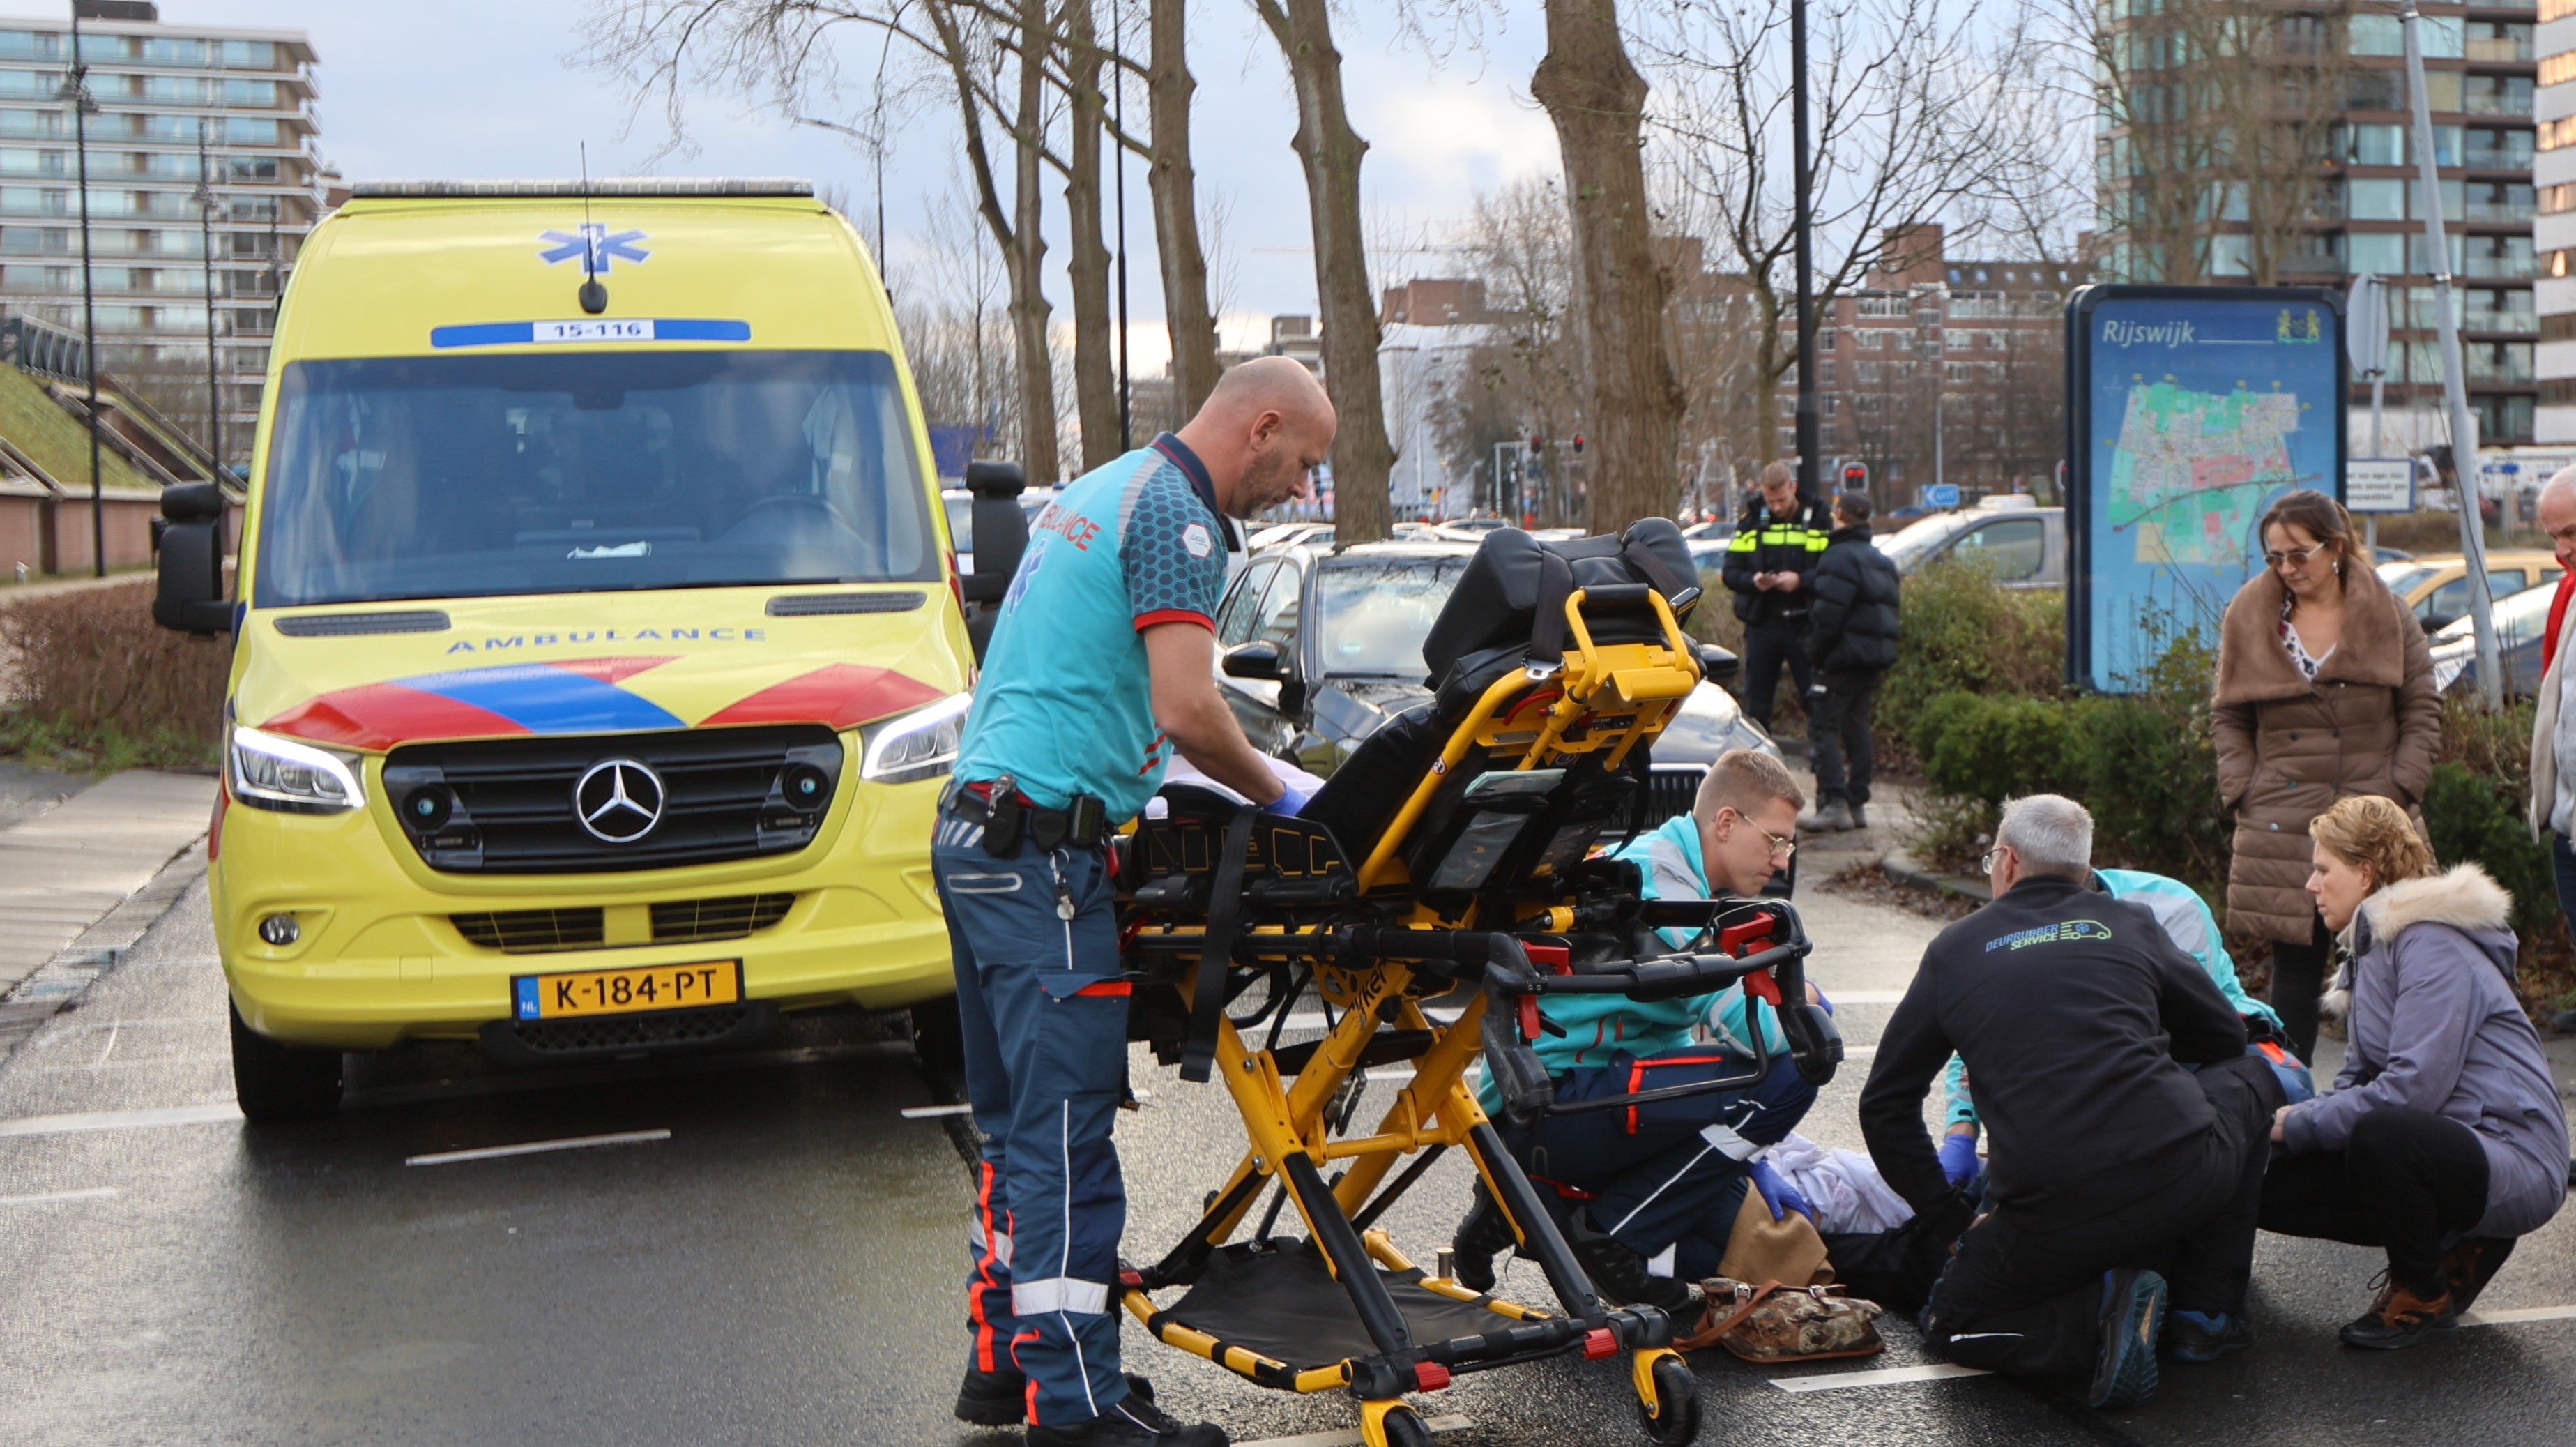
1216,543,1780,826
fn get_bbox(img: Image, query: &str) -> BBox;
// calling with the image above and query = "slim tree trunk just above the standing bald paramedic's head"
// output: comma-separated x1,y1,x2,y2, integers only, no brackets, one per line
1254,0,1396,540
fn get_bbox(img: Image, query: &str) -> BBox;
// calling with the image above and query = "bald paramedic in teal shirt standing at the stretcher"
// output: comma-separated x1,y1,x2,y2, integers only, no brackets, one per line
930,358,1334,1447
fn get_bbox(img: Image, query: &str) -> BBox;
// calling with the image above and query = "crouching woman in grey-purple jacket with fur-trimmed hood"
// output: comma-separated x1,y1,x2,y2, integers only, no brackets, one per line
2262,796,2568,1349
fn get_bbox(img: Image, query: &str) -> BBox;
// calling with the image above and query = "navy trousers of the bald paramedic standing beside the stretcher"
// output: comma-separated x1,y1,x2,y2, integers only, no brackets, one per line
930,808,1128,1426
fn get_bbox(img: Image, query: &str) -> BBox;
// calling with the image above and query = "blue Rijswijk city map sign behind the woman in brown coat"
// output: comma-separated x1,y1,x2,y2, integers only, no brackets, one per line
2066,286,2344,692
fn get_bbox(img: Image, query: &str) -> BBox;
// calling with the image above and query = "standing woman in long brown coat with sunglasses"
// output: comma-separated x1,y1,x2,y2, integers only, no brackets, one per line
2210,490,2442,1061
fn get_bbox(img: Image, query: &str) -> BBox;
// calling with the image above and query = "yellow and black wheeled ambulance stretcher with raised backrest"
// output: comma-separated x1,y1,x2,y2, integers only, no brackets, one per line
1120,584,1839,1447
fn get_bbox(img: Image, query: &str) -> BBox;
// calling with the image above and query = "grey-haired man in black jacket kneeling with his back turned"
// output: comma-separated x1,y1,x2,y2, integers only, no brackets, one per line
1860,793,2282,1406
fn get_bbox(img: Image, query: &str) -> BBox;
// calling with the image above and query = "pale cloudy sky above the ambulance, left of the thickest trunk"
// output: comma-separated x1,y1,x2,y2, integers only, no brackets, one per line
141,0,1556,373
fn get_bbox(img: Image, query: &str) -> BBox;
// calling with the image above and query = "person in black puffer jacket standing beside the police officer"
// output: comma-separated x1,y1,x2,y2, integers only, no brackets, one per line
1798,492,1898,834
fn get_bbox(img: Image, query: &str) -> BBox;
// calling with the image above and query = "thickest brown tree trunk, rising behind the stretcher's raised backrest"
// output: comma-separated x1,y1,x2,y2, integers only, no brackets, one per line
1530,0,1687,533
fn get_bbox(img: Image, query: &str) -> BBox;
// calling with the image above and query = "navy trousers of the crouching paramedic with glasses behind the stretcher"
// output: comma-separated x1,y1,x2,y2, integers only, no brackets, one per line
1502,1045,1816,1280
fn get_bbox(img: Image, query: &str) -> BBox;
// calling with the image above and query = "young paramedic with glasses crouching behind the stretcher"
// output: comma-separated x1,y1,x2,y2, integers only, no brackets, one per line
1453,749,1821,1310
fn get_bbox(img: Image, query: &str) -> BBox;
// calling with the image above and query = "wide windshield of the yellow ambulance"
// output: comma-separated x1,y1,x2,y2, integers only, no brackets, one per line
255,350,940,607
